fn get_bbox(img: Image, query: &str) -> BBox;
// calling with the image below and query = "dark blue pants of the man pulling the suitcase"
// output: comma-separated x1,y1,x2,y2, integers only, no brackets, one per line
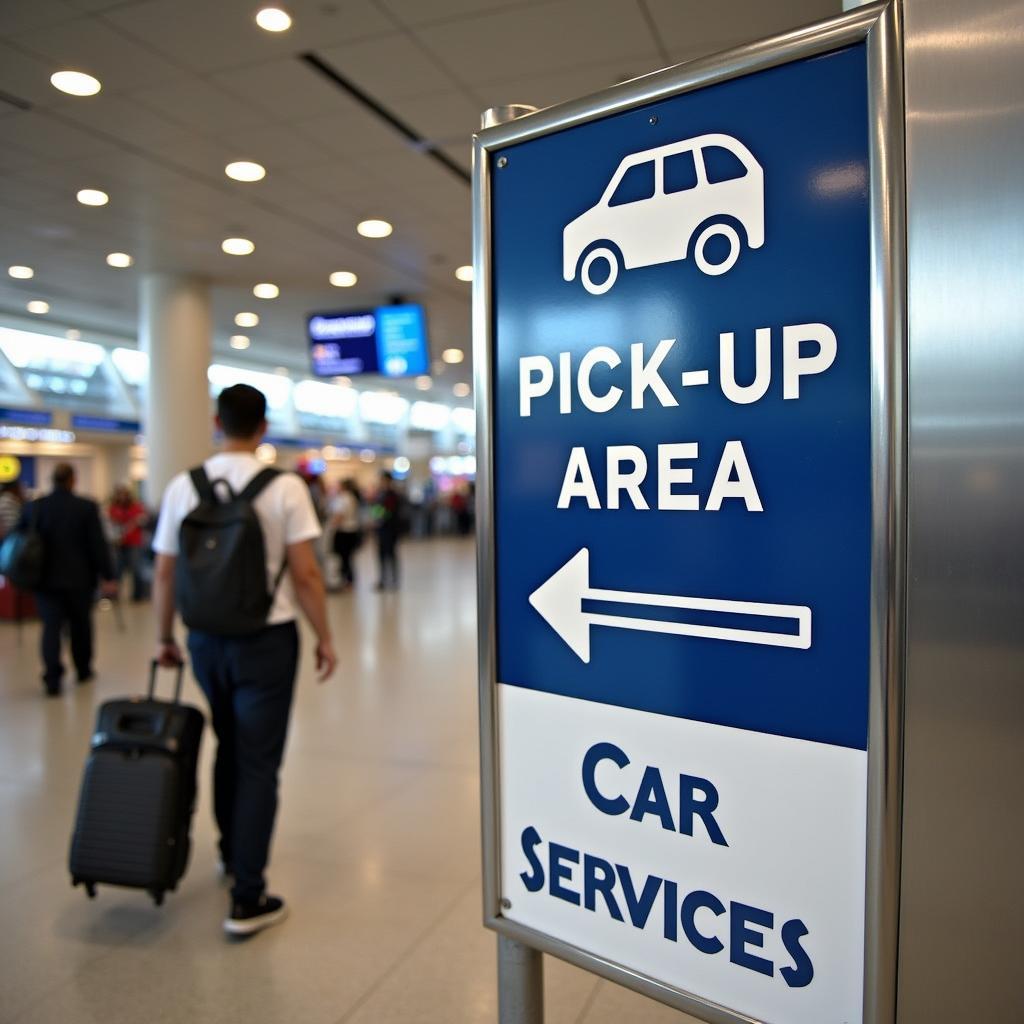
188,623,299,903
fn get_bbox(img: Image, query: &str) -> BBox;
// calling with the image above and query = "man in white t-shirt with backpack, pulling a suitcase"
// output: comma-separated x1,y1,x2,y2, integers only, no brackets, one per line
154,384,337,935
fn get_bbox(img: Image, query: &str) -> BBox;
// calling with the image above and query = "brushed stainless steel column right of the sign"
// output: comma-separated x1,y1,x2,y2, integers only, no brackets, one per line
898,0,1024,1024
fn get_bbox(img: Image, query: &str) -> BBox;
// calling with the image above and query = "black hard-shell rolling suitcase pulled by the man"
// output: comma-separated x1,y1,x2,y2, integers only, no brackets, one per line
70,662,203,906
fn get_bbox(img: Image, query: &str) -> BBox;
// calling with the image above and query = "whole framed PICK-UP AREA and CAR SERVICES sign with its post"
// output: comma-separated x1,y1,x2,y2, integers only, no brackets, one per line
474,4,904,1024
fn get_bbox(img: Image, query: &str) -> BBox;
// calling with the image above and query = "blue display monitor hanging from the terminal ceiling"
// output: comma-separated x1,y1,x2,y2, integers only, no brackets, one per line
307,305,430,385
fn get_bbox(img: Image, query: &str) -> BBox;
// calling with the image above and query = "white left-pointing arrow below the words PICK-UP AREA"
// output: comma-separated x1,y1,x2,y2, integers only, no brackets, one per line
529,548,811,664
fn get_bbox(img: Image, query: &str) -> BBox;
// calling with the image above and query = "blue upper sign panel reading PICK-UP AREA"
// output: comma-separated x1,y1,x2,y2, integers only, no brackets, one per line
490,45,871,751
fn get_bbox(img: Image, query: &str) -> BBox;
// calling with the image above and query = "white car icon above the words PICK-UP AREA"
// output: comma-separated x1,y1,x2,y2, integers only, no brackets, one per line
562,134,765,295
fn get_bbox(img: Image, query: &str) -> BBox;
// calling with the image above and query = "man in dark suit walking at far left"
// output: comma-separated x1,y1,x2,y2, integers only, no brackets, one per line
20,463,117,697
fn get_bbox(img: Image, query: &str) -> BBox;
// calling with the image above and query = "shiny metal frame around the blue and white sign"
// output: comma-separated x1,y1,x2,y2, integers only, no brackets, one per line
473,0,906,1024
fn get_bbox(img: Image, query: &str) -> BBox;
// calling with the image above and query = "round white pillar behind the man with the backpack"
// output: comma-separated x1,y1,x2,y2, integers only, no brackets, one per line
138,273,213,505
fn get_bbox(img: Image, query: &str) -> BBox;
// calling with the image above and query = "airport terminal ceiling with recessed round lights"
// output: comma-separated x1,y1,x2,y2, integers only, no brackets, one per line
0,0,839,395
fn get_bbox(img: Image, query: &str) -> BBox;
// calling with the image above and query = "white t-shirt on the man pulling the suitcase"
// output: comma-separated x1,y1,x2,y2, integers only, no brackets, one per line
153,452,321,626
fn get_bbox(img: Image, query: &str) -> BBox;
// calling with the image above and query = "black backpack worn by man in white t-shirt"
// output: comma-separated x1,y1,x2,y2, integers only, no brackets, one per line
174,466,288,636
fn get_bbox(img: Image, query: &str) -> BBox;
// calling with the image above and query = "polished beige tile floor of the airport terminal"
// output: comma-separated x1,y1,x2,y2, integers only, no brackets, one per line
0,541,691,1024
